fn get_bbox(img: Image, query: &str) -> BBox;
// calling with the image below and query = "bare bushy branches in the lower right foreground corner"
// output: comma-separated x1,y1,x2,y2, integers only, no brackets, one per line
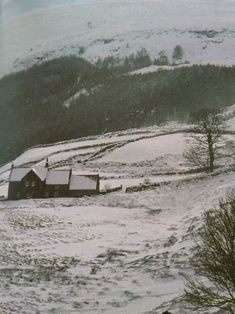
184,195,235,314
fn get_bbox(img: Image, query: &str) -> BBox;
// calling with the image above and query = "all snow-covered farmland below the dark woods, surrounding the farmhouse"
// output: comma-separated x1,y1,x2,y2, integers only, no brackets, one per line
0,112,235,314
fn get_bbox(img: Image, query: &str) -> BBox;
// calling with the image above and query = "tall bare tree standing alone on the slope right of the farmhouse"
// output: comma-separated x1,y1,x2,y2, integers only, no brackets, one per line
184,109,224,172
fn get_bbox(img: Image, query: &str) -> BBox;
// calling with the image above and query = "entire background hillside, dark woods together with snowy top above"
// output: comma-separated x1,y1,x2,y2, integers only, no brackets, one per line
0,0,235,164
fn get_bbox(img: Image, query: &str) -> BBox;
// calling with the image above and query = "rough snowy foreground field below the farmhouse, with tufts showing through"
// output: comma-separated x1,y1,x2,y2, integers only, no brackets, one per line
0,172,235,314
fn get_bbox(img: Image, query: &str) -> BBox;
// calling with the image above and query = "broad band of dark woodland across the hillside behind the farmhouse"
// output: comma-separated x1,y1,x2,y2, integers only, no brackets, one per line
0,55,235,164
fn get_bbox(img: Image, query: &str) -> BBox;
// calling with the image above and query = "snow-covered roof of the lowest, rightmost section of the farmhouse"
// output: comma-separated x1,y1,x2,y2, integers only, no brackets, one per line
69,175,98,190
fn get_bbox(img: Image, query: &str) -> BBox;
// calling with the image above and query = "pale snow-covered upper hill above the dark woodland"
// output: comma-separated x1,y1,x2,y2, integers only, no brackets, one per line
0,0,235,76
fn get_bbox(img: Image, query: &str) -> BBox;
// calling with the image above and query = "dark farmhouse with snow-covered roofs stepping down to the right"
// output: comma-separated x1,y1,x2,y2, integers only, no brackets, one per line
8,163,100,200
